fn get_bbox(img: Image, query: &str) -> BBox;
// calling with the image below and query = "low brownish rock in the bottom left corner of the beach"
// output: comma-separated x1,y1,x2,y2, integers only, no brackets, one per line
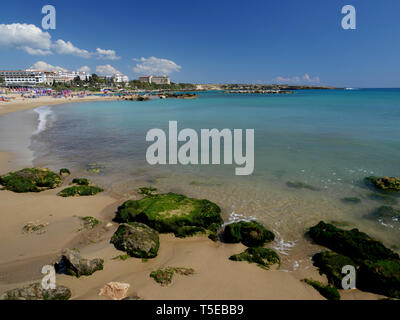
0,283,71,300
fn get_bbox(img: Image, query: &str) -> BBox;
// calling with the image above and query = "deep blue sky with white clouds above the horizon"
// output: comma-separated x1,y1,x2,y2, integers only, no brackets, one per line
0,0,400,87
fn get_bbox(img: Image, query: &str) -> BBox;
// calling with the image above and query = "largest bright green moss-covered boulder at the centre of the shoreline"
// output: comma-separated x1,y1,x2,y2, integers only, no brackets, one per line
114,193,223,237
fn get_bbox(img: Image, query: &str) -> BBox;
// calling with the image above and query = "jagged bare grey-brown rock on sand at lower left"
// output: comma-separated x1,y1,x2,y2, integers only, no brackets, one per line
55,249,104,278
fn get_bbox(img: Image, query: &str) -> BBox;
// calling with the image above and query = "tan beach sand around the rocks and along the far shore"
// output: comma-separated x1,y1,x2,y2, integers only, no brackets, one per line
0,98,379,300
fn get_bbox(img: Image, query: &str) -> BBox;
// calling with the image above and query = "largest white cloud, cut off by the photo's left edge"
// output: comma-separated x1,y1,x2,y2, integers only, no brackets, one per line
0,23,51,55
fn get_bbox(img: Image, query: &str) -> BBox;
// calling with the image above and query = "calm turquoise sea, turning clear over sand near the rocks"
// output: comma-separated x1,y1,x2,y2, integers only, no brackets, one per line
25,89,400,258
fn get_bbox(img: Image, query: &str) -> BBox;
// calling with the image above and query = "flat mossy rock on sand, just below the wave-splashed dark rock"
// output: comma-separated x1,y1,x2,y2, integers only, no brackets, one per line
229,247,280,270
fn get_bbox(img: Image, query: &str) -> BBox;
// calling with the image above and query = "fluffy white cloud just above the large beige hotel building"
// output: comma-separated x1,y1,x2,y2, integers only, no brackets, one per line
133,57,182,75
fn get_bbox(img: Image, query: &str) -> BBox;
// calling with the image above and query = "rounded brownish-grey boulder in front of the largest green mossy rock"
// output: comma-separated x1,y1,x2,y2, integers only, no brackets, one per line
111,222,160,258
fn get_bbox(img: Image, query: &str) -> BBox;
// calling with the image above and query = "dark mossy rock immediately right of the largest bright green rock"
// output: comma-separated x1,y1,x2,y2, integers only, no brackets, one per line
224,221,275,247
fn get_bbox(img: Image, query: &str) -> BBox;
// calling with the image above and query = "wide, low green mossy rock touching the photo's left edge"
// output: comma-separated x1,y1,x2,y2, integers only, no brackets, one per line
0,168,62,193
